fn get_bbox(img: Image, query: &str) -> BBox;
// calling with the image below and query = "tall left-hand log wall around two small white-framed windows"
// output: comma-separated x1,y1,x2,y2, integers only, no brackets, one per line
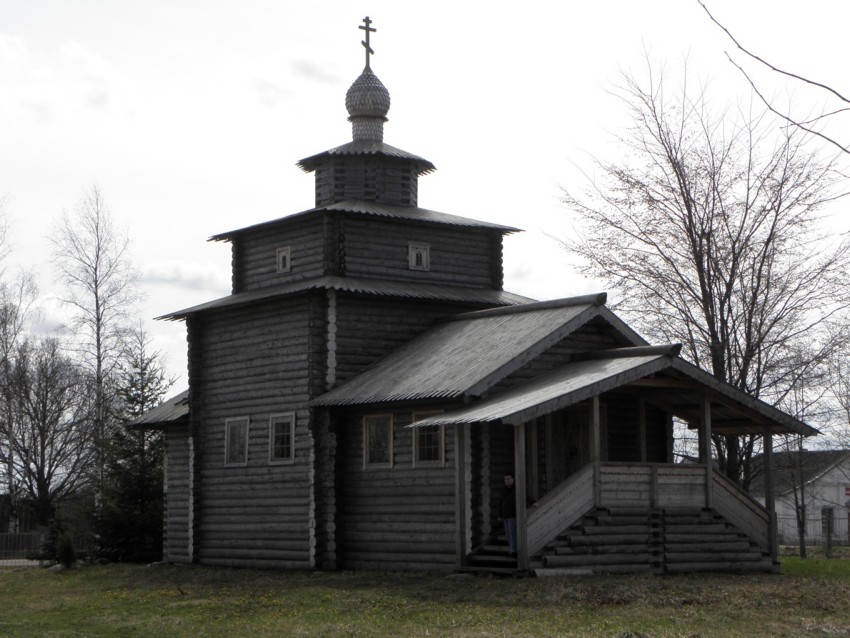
194,295,323,568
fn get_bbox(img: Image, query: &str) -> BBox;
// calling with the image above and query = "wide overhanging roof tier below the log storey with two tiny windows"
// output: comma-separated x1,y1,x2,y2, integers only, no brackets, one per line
157,275,531,321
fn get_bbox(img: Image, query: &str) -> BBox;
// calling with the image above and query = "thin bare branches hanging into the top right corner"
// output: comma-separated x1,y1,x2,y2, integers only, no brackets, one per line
697,0,850,154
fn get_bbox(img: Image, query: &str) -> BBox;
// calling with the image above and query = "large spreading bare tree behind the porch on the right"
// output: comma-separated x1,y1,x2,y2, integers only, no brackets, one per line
563,63,850,487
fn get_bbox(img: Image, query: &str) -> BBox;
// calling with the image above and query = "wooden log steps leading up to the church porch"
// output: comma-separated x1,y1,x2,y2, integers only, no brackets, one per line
465,509,776,576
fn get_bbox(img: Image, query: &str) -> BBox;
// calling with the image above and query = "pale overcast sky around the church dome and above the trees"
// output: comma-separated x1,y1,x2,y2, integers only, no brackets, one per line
0,0,850,390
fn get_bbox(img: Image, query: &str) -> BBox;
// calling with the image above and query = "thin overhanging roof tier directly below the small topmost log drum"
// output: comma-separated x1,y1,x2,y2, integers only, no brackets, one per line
208,199,519,241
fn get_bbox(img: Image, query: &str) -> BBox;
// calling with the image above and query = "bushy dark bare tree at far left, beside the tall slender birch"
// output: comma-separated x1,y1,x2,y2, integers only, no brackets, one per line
0,339,93,525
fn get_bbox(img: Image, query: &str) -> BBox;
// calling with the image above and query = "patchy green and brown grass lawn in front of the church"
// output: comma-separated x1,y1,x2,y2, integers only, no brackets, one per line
0,558,850,638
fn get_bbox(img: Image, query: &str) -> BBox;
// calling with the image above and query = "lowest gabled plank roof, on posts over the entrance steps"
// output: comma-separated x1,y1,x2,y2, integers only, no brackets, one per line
408,346,818,436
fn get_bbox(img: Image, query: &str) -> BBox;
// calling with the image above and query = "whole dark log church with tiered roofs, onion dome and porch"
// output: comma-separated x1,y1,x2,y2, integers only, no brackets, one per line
140,18,815,574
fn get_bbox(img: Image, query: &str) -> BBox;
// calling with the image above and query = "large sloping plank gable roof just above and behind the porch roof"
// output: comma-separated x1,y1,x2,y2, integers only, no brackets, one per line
311,293,646,406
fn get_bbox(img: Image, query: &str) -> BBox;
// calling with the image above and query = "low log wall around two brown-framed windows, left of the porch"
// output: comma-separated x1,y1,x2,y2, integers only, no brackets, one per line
336,408,456,570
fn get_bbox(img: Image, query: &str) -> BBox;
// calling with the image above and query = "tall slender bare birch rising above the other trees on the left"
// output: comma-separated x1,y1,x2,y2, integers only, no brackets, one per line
51,186,139,490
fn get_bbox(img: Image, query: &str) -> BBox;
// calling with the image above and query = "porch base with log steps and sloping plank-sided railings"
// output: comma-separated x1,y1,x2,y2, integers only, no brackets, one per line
461,463,776,575
